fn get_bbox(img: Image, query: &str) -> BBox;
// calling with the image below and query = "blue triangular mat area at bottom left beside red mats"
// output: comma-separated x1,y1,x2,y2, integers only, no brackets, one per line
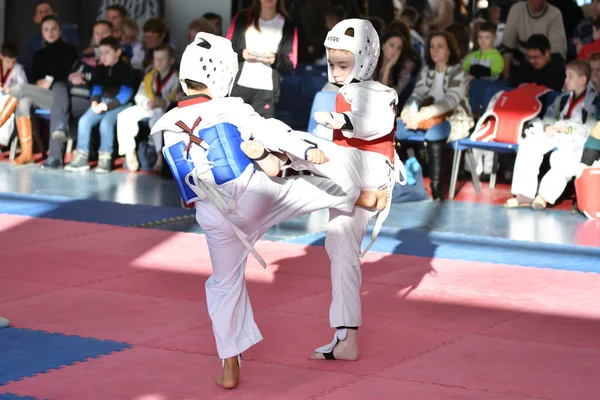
0,327,131,384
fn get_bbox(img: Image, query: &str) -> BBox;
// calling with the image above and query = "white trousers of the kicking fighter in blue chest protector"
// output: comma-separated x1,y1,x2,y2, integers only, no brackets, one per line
195,167,360,358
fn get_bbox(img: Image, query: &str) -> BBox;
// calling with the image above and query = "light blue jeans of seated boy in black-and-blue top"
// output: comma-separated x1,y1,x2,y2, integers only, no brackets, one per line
77,99,129,154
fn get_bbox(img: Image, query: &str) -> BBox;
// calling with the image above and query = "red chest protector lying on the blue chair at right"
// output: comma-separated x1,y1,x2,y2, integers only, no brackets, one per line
471,83,550,144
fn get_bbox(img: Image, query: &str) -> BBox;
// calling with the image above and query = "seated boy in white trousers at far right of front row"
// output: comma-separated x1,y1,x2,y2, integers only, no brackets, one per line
506,60,597,210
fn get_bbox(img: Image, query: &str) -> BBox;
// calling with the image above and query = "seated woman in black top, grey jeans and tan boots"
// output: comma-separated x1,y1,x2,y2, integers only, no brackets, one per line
0,15,77,164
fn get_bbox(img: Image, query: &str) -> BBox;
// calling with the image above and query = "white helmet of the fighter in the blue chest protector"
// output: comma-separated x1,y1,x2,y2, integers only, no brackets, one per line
179,32,238,98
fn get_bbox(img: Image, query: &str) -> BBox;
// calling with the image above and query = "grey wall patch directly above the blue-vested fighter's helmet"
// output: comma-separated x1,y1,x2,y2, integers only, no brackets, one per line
164,0,231,50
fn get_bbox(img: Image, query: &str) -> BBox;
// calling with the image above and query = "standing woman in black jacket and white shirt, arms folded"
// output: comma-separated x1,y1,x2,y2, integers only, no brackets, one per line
227,0,298,118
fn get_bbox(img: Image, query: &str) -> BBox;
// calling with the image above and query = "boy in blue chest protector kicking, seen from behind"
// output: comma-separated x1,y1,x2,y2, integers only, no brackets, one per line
152,33,384,389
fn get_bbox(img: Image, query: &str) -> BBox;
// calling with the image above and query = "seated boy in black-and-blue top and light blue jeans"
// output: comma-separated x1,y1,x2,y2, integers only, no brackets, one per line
65,37,135,173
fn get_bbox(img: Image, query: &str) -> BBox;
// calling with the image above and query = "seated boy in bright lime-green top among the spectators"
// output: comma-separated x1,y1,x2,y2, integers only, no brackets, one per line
463,22,504,80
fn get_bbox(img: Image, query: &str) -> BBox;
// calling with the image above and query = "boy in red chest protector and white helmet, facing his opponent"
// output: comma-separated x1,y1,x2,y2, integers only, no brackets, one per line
291,19,406,360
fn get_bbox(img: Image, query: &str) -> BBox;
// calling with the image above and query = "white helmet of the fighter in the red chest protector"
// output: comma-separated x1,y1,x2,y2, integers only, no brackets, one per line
325,18,380,84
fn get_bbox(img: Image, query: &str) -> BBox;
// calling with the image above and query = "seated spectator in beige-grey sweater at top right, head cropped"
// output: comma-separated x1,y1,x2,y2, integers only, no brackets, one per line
502,0,567,81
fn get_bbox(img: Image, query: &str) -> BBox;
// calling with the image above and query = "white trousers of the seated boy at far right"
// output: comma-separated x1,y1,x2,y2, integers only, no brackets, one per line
511,132,585,204
